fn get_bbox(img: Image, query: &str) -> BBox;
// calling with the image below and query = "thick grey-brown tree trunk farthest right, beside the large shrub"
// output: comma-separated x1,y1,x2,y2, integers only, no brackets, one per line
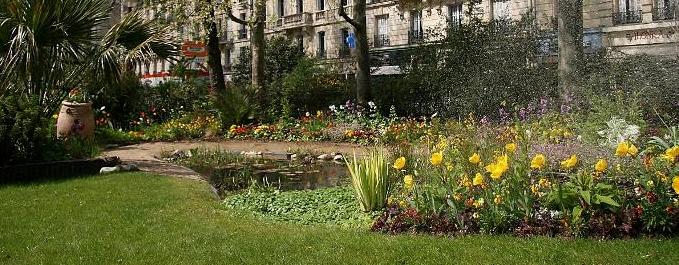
557,0,583,99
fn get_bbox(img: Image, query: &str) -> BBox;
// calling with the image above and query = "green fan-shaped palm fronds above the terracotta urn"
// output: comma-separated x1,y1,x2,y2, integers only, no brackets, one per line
0,0,177,115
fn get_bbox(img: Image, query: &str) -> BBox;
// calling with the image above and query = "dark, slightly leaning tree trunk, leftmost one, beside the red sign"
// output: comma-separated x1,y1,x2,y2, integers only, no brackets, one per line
206,4,226,98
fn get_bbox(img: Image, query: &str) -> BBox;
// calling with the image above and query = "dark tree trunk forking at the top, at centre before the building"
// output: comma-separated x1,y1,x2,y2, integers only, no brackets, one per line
338,0,371,106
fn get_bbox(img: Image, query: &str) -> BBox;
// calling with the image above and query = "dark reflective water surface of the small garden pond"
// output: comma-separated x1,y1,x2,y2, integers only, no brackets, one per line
193,158,351,196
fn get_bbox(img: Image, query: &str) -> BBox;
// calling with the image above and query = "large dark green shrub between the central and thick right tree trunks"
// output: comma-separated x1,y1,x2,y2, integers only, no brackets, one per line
373,16,557,118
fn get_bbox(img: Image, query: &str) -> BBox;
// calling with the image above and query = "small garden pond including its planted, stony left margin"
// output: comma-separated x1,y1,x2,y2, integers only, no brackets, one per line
163,149,351,197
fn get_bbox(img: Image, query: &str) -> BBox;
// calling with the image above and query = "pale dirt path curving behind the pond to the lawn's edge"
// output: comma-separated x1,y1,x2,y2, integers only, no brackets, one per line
102,140,365,181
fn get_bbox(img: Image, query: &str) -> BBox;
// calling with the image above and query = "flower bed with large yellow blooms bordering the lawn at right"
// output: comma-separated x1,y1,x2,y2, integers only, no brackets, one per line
372,123,679,237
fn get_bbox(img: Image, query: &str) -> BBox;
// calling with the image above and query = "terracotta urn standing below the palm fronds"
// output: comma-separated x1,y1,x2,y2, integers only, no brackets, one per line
57,101,95,139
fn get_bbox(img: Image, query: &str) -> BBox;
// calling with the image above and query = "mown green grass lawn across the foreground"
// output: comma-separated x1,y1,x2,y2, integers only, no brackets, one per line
0,173,679,264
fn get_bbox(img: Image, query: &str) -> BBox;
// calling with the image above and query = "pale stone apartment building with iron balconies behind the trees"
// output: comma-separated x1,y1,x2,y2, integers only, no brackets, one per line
121,0,679,82
